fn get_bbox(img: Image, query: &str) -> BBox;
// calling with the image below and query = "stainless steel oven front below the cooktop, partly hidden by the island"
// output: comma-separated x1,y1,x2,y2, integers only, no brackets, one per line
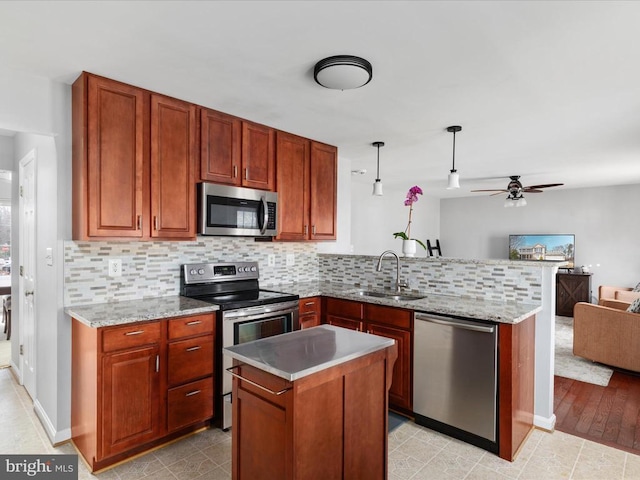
220,301,299,430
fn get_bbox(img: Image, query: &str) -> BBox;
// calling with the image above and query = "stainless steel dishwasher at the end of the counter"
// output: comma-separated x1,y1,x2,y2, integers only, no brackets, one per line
413,312,498,452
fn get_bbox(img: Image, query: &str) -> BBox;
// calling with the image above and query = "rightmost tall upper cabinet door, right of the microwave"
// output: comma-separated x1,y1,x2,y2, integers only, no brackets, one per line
309,142,338,240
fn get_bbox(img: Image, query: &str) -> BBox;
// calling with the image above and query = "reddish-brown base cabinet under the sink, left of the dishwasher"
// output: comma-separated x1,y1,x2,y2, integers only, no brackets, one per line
325,298,413,415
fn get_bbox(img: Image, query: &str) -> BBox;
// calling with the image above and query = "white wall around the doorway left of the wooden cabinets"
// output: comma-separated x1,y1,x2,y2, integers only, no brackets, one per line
0,67,71,442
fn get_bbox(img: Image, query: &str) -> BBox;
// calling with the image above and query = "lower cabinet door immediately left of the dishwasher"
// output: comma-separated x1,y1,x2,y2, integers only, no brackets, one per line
366,323,413,411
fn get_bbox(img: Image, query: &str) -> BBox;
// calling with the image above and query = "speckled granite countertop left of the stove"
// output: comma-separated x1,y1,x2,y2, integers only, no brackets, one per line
64,295,218,328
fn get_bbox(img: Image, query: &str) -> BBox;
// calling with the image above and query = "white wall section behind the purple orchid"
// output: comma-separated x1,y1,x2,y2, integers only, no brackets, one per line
351,179,440,257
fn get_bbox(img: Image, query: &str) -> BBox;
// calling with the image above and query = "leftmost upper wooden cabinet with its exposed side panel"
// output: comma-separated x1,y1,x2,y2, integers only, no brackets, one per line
72,74,148,240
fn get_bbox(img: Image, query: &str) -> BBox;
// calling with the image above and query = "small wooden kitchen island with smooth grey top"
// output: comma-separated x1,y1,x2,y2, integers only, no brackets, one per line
224,325,397,480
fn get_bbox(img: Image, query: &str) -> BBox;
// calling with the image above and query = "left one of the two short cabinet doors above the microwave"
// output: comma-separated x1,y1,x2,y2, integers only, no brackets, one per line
200,108,242,185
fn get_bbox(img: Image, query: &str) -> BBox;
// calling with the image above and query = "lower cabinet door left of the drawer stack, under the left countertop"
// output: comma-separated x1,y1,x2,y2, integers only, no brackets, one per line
101,345,162,458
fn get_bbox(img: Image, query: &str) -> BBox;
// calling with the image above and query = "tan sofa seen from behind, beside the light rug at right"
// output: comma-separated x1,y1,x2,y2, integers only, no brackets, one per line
573,298,640,372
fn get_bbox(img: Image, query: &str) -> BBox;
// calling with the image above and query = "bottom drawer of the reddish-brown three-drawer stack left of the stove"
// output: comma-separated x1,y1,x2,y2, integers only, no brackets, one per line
167,377,213,431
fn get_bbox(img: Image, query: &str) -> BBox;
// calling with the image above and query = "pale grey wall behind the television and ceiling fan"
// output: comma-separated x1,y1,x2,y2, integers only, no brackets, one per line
440,185,640,297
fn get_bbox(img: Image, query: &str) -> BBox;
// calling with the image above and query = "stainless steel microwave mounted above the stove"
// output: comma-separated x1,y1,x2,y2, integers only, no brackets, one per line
198,183,278,237
